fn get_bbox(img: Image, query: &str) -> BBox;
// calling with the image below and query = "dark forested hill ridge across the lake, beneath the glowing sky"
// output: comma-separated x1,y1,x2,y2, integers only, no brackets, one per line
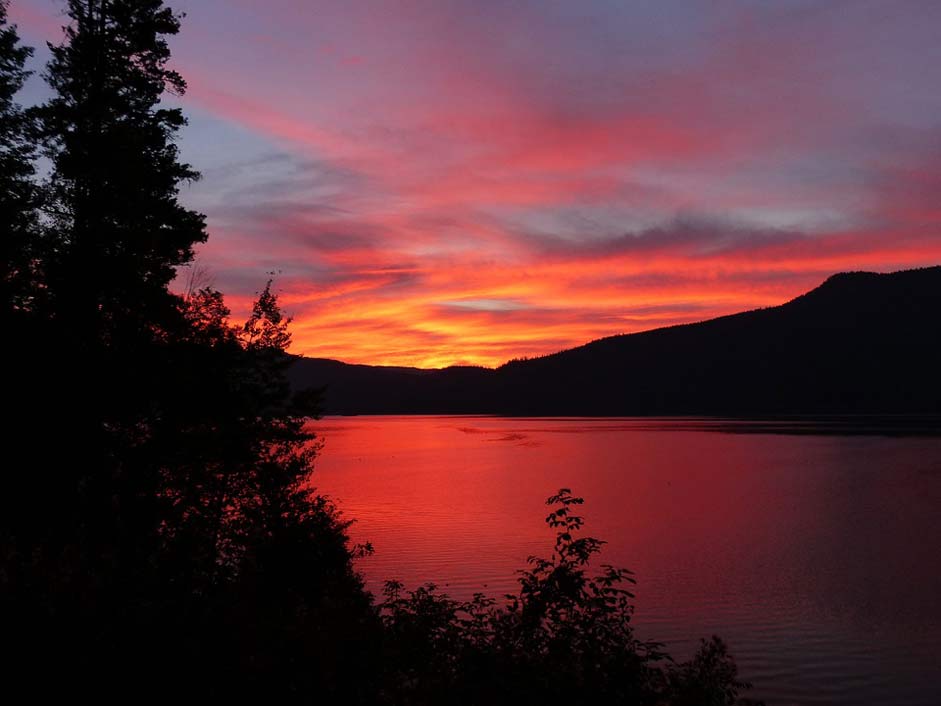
292,267,941,415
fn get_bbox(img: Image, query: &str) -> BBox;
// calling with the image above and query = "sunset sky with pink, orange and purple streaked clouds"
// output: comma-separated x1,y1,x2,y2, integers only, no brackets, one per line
10,0,941,367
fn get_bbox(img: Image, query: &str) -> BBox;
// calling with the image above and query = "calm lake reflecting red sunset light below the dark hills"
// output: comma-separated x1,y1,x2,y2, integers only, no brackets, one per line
314,416,941,706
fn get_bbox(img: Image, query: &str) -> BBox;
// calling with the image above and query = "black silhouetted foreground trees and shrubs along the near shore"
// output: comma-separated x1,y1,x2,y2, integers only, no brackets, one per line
0,0,756,705
